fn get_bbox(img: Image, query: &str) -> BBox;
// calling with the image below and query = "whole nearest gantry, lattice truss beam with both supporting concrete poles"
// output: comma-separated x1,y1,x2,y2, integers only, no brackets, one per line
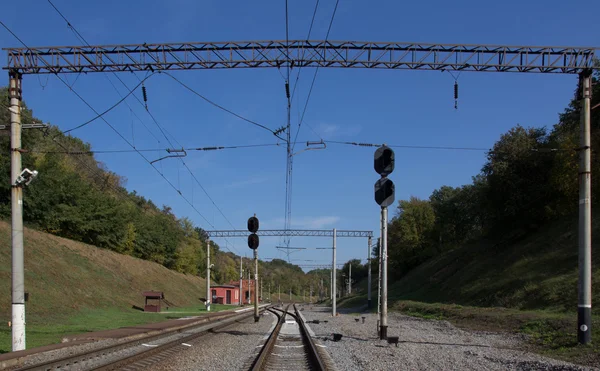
4,40,598,350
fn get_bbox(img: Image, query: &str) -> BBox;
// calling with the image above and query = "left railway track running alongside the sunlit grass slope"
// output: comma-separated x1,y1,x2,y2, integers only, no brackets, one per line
17,307,267,371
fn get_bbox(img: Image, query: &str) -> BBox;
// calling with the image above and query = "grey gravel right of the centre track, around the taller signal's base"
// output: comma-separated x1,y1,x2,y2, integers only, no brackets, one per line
302,306,600,370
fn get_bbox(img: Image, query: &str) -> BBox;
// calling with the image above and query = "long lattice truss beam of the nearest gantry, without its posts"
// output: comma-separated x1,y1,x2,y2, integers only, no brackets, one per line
4,40,597,74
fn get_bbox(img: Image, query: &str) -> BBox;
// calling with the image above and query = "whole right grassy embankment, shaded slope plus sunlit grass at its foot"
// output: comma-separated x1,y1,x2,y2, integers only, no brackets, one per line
340,219,600,366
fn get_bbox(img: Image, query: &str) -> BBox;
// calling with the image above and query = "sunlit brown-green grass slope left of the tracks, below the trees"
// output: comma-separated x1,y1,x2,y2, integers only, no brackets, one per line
0,221,211,352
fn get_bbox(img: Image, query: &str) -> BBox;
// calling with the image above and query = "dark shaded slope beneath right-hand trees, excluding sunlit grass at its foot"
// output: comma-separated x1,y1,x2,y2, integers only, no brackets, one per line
390,220,600,313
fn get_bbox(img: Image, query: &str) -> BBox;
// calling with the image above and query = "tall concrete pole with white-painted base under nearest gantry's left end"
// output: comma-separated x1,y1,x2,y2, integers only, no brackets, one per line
8,71,25,352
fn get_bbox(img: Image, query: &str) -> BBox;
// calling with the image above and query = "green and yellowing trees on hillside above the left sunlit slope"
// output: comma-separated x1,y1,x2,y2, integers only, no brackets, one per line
0,88,329,295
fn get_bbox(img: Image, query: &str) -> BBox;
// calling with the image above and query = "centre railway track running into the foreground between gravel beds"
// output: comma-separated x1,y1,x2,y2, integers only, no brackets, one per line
250,305,331,371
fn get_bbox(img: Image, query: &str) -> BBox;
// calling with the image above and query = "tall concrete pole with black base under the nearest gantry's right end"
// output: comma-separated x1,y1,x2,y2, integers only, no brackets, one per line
577,70,592,344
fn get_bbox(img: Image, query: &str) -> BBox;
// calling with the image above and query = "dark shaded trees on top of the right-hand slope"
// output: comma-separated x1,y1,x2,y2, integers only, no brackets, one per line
374,70,600,280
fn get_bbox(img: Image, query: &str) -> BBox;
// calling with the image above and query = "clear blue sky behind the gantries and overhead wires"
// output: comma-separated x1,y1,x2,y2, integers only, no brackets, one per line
0,0,600,272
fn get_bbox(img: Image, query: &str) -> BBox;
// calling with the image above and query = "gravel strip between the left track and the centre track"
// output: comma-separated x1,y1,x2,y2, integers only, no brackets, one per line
147,311,277,371
